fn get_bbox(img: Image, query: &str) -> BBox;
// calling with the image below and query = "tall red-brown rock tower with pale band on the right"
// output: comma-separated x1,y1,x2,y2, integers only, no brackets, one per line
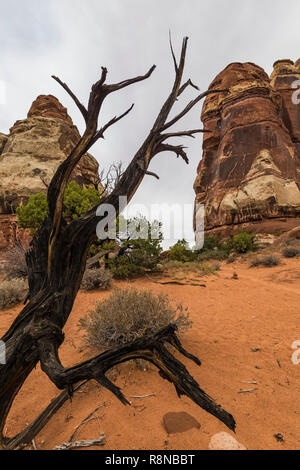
194,60,300,235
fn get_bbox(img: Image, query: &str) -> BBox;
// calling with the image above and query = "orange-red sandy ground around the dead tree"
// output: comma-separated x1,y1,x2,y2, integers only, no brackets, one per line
0,260,300,450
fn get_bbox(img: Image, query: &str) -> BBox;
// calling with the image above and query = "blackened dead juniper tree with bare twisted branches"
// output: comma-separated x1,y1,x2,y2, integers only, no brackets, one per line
0,38,235,449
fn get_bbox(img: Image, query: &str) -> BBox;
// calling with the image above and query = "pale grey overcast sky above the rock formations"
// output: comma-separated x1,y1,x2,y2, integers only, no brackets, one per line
0,0,300,248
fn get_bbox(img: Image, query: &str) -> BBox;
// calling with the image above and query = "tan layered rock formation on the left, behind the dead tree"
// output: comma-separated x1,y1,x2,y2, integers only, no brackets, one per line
0,95,99,249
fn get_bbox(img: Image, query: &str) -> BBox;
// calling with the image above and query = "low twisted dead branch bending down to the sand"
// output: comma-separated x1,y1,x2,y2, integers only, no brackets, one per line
39,324,235,431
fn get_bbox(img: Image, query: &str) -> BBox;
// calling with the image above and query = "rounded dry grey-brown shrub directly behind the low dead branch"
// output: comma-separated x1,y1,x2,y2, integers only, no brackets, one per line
80,288,191,351
